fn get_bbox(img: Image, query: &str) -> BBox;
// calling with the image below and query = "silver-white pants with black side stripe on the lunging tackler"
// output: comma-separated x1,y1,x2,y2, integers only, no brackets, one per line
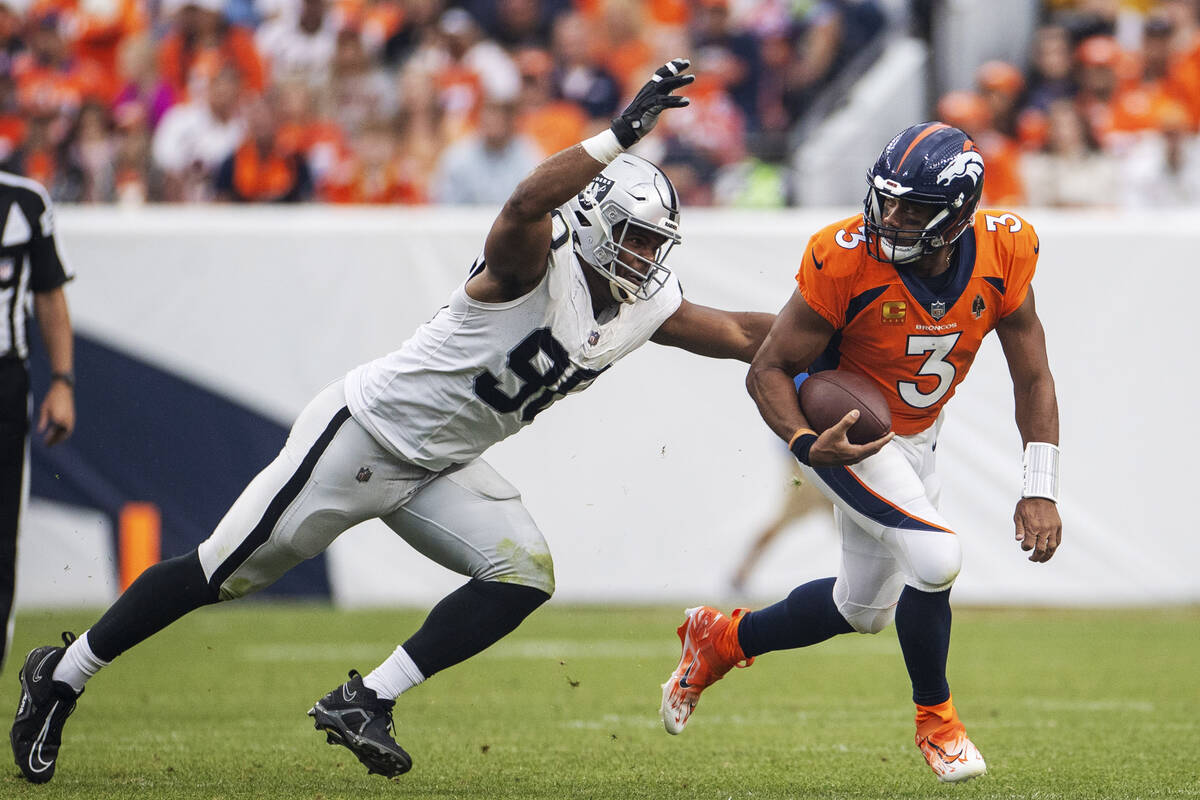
199,380,554,600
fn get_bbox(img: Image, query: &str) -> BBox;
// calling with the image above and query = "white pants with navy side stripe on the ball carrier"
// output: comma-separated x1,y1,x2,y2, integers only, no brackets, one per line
802,417,962,633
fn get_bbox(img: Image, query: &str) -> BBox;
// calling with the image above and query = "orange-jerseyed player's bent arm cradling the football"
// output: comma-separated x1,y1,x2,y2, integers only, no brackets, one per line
746,290,892,467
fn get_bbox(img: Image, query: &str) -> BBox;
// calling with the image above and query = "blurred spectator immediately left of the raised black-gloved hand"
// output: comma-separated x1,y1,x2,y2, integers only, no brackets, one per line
552,13,622,124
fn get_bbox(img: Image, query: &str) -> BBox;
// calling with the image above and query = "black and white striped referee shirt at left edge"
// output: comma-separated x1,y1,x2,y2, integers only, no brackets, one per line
0,172,74,359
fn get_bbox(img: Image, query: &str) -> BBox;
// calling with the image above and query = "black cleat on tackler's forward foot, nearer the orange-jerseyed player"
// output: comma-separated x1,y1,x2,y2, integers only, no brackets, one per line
308,669,413,777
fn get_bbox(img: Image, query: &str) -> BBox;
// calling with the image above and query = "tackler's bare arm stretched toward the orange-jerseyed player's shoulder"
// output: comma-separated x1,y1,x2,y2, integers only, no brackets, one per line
650,300,775,363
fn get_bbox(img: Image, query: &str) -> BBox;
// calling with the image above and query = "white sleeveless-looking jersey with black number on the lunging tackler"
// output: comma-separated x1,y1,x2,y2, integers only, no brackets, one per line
346,212,683,470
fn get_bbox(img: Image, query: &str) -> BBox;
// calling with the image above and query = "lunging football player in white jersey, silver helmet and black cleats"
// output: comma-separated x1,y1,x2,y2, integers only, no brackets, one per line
11,59,774,783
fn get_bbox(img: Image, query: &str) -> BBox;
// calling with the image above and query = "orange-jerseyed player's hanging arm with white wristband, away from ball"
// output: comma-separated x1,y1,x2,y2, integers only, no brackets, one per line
996,289,1062,563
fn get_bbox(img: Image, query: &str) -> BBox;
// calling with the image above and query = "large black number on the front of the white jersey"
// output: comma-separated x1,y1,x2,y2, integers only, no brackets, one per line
475,327,607,422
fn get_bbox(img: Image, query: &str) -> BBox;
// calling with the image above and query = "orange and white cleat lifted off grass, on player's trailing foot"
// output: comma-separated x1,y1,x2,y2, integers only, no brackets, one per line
661,606,754,734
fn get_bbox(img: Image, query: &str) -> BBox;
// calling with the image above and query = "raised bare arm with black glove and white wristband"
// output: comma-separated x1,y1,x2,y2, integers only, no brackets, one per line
480,59,695,299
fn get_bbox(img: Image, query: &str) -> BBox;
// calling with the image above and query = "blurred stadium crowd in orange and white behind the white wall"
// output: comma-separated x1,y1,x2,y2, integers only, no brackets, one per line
0,0,1200,206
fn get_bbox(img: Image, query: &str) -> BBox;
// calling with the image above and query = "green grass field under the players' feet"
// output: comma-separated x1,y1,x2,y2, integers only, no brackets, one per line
0,602,1200,800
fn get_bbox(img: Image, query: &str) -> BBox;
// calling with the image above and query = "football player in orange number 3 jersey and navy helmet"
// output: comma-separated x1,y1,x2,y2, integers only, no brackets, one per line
662,122,1062,781
